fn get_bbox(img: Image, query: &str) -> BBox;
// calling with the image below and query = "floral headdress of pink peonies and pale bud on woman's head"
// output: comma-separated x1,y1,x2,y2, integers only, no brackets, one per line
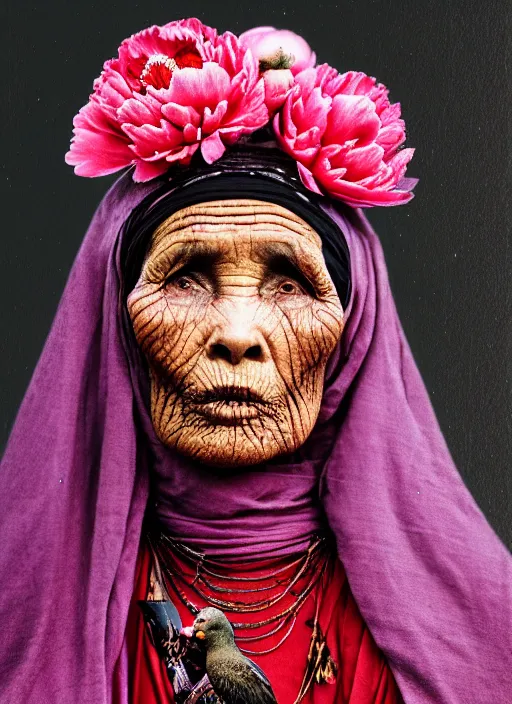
66,18,417,207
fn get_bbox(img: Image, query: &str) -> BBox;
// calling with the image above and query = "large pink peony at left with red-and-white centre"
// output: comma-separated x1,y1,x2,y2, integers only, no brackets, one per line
66,19,269,181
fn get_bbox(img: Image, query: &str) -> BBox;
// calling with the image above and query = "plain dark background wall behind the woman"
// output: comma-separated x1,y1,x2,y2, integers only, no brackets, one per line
0,0,512,545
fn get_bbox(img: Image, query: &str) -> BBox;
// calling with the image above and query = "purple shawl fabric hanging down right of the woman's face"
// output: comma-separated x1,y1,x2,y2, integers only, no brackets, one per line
321,201,512,704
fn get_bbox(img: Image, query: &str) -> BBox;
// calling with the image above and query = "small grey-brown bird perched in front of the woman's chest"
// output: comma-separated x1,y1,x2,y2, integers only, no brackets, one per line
183,606,277,704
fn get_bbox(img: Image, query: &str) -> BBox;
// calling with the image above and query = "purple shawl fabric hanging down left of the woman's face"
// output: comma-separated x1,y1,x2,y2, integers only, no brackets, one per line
0,176,157,704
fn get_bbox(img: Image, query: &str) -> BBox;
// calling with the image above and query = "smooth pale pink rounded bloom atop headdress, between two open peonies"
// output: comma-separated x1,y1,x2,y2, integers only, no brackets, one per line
240,27,316,75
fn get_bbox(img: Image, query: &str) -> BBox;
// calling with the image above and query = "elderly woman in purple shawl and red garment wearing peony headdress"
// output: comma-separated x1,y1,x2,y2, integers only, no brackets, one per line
0,15,512,704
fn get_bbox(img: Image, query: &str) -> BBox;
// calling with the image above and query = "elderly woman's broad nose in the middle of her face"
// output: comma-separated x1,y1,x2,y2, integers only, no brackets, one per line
207,311,270,364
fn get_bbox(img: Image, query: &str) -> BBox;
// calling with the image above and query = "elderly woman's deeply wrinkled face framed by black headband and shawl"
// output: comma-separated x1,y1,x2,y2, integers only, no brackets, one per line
128,200,343,466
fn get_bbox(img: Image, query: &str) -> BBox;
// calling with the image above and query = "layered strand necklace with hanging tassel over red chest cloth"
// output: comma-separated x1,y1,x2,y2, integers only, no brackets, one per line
148,530,337,704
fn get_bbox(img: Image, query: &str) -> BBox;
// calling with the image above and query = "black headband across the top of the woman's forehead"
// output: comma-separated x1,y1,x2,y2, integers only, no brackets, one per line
121,171,351,309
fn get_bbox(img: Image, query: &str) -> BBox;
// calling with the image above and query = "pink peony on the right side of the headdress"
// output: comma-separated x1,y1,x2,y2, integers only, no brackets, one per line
273,64,416,207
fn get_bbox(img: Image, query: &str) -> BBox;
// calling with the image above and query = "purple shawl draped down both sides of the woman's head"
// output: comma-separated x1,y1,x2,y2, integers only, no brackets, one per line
0,175,512,704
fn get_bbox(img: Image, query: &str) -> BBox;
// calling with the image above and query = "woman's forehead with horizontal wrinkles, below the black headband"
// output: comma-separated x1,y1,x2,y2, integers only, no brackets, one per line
150,198,322,254
